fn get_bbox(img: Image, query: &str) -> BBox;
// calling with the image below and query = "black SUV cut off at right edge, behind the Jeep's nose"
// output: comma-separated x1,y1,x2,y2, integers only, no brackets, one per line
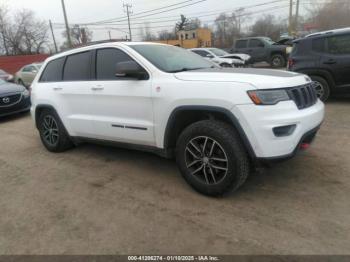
288,28,350,101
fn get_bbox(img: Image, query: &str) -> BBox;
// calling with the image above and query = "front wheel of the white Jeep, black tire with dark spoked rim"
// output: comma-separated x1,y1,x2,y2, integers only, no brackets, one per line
176,120,250,196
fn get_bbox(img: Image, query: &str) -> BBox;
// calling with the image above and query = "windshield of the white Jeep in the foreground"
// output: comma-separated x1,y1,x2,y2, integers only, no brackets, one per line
130,45,214,73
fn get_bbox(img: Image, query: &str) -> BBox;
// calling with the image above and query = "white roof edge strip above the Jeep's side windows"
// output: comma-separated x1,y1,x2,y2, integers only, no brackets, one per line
45,42,166,61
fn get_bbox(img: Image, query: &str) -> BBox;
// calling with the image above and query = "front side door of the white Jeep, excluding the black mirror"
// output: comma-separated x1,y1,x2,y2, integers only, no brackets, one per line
90,48,155,145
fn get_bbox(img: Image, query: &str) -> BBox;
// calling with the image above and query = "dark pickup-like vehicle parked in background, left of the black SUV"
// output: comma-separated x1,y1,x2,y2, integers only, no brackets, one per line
231,37,288,68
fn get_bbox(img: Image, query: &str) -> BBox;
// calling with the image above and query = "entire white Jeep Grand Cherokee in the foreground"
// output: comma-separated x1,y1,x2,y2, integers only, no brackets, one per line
31,42,324,195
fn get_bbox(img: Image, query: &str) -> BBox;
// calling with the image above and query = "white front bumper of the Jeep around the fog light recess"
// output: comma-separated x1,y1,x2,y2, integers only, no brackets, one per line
232,100,324,159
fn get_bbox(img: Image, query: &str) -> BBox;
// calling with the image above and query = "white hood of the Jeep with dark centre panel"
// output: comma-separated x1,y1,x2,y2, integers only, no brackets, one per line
174,68,311,89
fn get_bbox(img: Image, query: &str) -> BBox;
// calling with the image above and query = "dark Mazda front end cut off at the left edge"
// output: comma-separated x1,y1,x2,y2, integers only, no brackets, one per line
0,79,30,117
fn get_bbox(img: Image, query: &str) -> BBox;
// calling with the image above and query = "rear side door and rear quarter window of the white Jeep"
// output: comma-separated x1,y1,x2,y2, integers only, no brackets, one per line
39,51,93,137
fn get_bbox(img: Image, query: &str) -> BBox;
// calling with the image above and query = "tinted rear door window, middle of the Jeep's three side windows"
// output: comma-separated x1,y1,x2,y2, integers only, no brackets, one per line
63,52,90,81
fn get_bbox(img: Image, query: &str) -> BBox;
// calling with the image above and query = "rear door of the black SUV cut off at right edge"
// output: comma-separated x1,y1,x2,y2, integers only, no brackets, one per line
321,34,350,87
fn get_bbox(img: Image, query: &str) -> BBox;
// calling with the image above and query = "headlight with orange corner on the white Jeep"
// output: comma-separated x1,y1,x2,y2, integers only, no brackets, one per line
248,89,290,105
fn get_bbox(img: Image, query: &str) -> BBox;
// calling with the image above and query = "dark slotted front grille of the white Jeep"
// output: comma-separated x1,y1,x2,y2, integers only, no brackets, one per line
288,83,317,109
